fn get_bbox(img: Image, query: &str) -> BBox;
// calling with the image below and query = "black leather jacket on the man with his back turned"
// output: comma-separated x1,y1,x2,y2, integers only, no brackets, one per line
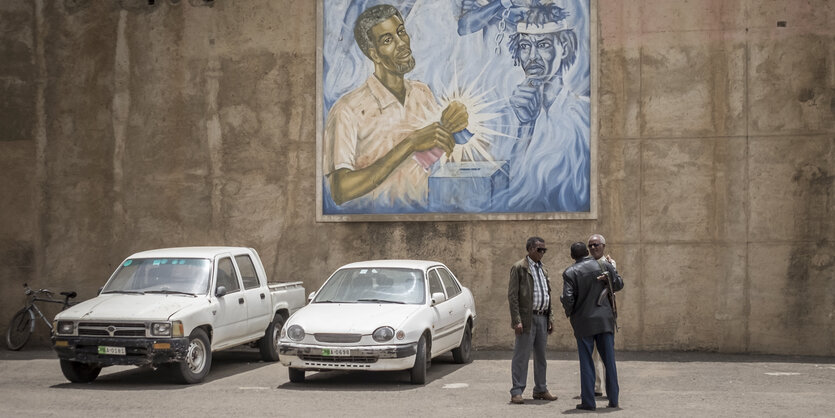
560,257,623,337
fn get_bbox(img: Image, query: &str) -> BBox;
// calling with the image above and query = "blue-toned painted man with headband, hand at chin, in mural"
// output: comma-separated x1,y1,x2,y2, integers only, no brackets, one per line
500,1,590,211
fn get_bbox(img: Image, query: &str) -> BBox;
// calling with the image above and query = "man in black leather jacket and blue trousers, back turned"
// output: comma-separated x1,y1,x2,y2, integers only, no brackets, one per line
560,242,623,410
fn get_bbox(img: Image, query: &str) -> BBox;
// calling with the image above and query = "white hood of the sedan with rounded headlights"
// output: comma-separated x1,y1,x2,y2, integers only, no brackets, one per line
290,303,422,335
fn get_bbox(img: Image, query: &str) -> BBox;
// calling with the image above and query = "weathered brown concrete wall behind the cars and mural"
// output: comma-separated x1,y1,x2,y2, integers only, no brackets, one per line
0,0,835,355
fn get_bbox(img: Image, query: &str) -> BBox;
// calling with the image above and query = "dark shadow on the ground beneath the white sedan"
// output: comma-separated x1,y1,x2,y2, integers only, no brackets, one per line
278,354,467,392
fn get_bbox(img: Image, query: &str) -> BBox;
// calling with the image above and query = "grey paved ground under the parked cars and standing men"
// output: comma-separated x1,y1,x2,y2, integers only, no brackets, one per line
0,349,835,417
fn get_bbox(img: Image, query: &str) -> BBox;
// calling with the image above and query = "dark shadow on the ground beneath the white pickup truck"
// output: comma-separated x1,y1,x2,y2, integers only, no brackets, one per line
51,348,275,390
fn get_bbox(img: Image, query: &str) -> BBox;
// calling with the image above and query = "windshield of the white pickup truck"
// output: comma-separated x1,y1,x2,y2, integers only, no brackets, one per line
102,258,212,295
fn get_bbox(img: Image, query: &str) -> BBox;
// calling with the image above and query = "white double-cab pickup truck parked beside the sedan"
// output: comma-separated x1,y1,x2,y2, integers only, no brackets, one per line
52,247,306,383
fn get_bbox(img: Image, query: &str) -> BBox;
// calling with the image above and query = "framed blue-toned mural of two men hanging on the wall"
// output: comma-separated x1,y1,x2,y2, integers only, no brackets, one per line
316,0,597,222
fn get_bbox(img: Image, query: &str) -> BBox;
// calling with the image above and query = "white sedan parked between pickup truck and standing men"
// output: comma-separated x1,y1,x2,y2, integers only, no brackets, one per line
279,260,476,385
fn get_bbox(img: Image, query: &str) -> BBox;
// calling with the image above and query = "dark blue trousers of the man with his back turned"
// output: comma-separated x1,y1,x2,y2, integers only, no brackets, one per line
577,332,620,407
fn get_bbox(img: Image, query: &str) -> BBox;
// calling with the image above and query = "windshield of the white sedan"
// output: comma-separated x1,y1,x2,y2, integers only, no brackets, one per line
313,268,426,304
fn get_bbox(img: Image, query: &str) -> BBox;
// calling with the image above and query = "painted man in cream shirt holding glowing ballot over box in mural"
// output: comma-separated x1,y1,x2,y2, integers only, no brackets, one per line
323,5,468,213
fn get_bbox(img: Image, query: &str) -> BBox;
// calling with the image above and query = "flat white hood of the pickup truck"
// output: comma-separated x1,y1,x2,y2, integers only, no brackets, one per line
56,294,205,321
